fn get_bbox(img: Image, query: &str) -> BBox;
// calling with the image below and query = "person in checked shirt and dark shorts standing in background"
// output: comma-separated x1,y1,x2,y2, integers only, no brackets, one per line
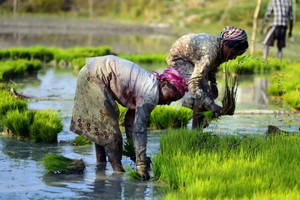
260,0,294,61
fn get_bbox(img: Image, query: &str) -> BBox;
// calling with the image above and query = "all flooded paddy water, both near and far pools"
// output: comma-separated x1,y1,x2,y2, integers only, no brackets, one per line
0,17,300,200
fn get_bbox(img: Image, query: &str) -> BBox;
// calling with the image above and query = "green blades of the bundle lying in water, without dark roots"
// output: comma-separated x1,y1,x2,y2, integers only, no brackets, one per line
43,154,76,173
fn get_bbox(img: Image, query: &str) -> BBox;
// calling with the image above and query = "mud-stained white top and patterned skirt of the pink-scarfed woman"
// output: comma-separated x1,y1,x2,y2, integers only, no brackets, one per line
70,55,159,166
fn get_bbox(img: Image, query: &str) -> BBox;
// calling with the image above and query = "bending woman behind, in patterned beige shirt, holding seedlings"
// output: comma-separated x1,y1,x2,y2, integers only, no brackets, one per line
167,26,248,128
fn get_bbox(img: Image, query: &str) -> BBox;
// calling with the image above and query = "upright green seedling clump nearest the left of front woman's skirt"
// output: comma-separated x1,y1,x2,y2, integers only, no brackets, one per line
30,110,63,143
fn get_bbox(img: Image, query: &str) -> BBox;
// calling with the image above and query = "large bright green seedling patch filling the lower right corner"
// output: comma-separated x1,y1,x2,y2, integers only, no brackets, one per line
153,129,300,199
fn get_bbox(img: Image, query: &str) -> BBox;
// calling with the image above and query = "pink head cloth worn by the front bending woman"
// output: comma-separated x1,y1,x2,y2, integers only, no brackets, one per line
152,67,188,97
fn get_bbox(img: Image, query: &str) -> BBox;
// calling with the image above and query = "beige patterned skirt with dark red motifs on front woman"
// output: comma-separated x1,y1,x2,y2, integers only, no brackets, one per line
70,66,122,149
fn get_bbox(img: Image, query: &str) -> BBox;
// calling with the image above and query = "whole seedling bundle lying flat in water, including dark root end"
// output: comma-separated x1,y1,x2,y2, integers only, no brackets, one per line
43,154,85,173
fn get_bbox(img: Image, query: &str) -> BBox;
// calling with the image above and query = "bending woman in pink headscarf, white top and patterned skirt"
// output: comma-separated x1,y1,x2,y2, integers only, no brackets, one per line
70,55,187,179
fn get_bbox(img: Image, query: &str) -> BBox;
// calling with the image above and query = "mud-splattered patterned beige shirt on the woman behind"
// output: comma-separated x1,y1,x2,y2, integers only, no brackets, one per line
167,33,223,106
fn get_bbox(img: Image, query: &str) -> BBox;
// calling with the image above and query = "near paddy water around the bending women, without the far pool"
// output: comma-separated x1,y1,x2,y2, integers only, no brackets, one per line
0,67,300,199
